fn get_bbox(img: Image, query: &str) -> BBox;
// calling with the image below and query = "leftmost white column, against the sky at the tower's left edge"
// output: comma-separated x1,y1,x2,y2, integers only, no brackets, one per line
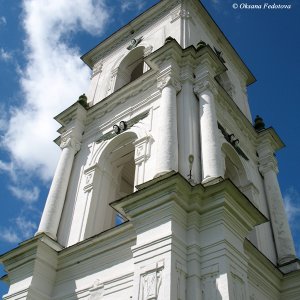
36,137,80,240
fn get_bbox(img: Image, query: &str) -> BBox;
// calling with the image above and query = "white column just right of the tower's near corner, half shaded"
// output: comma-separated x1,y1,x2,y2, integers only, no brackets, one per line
194,79,224,183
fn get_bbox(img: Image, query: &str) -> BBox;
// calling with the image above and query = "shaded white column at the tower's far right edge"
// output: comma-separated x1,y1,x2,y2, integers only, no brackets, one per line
257,142,296,265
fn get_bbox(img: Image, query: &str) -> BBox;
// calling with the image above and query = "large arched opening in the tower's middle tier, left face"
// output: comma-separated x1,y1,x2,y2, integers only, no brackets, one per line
84,132,137,238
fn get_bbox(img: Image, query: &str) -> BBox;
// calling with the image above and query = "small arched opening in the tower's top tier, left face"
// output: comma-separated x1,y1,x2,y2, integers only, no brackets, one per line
114,46,146,91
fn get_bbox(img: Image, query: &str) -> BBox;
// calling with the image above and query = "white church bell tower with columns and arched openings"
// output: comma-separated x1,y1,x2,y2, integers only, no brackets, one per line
1,0,300,300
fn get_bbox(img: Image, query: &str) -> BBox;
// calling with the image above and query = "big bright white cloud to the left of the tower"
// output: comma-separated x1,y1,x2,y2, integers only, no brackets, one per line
1,0,108,180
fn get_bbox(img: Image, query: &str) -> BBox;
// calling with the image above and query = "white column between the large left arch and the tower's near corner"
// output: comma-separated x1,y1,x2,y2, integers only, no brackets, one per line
155,75,181,177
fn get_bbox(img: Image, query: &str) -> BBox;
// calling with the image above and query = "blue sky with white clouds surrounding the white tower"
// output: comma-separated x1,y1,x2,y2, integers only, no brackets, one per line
0,0,300,295
